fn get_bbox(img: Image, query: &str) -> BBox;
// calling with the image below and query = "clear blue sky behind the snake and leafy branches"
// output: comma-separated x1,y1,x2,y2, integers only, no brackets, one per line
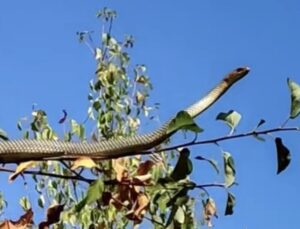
0,0,300,229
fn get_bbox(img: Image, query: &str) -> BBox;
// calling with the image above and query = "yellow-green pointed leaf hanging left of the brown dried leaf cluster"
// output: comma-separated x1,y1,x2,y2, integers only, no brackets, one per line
75,179,104,212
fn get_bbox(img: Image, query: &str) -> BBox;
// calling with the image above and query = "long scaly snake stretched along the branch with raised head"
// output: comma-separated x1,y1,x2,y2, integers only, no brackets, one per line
0,67,250,164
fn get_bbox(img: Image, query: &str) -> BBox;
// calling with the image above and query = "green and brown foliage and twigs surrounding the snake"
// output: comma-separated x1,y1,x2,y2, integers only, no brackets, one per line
0,8,300,228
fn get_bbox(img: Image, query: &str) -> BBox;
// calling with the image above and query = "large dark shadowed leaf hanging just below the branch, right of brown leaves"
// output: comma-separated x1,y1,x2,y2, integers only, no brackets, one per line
170,148,193,181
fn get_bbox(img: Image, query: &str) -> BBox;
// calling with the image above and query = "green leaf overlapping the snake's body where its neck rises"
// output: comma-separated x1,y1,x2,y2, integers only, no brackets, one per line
167,111,203,134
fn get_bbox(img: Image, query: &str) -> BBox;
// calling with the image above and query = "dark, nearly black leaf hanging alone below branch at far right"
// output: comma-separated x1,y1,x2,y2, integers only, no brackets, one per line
275,138,291,174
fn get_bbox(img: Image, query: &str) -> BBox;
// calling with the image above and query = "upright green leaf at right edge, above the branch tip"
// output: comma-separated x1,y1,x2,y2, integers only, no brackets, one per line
287,79,300,119
